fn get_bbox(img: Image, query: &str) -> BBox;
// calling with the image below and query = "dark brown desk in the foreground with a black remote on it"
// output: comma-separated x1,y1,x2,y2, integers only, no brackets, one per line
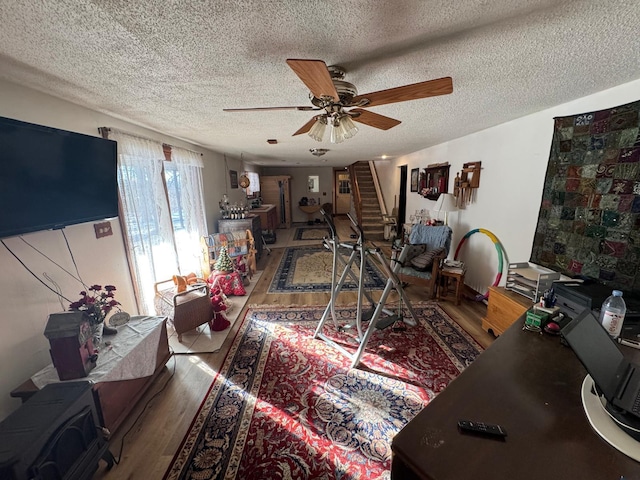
392,317,640,480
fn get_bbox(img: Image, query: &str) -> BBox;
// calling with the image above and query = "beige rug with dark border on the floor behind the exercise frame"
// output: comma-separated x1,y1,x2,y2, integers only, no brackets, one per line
267,247,387,293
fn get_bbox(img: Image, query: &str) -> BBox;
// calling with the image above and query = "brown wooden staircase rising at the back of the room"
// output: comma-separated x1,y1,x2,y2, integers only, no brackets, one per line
349,162,384,240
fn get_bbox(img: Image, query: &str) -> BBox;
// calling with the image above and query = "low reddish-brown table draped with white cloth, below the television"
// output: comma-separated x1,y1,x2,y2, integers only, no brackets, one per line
11,316,171,433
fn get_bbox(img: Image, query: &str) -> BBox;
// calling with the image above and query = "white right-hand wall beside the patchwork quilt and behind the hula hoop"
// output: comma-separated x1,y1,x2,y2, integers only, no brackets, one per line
385,80,640,293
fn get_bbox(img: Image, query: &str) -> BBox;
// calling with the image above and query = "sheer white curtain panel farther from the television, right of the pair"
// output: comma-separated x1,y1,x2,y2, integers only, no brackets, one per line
165,147,207,275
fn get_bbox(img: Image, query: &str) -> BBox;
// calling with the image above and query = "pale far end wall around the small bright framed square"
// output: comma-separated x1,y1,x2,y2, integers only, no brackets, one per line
262,167,333,223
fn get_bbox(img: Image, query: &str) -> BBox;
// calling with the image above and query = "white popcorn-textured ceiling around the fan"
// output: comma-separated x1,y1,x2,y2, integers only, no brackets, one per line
0,0,640,166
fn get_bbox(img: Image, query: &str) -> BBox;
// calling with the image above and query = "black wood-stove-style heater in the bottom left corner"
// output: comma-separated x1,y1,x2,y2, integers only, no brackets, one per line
0,381,113,480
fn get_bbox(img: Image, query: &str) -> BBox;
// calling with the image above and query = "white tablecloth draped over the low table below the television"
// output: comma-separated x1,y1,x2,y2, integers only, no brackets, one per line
31,316,165,388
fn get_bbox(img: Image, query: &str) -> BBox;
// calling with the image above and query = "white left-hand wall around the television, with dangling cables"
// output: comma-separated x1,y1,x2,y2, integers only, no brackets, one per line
0,81,232,419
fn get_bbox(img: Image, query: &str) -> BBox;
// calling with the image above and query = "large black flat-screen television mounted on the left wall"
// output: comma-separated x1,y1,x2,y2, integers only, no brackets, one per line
0,117,118,238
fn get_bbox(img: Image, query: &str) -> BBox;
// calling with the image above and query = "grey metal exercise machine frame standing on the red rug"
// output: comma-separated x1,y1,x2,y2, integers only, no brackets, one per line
313,210,418,368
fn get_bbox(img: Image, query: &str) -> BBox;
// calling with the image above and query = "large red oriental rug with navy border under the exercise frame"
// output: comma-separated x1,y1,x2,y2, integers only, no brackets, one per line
164,303,481,480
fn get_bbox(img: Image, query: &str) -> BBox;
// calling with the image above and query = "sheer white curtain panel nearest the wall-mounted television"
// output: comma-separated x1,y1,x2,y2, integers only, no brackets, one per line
109,130,178,314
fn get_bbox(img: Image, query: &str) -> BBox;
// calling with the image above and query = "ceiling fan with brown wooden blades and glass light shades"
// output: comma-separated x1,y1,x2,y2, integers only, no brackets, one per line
223,59,453,143
